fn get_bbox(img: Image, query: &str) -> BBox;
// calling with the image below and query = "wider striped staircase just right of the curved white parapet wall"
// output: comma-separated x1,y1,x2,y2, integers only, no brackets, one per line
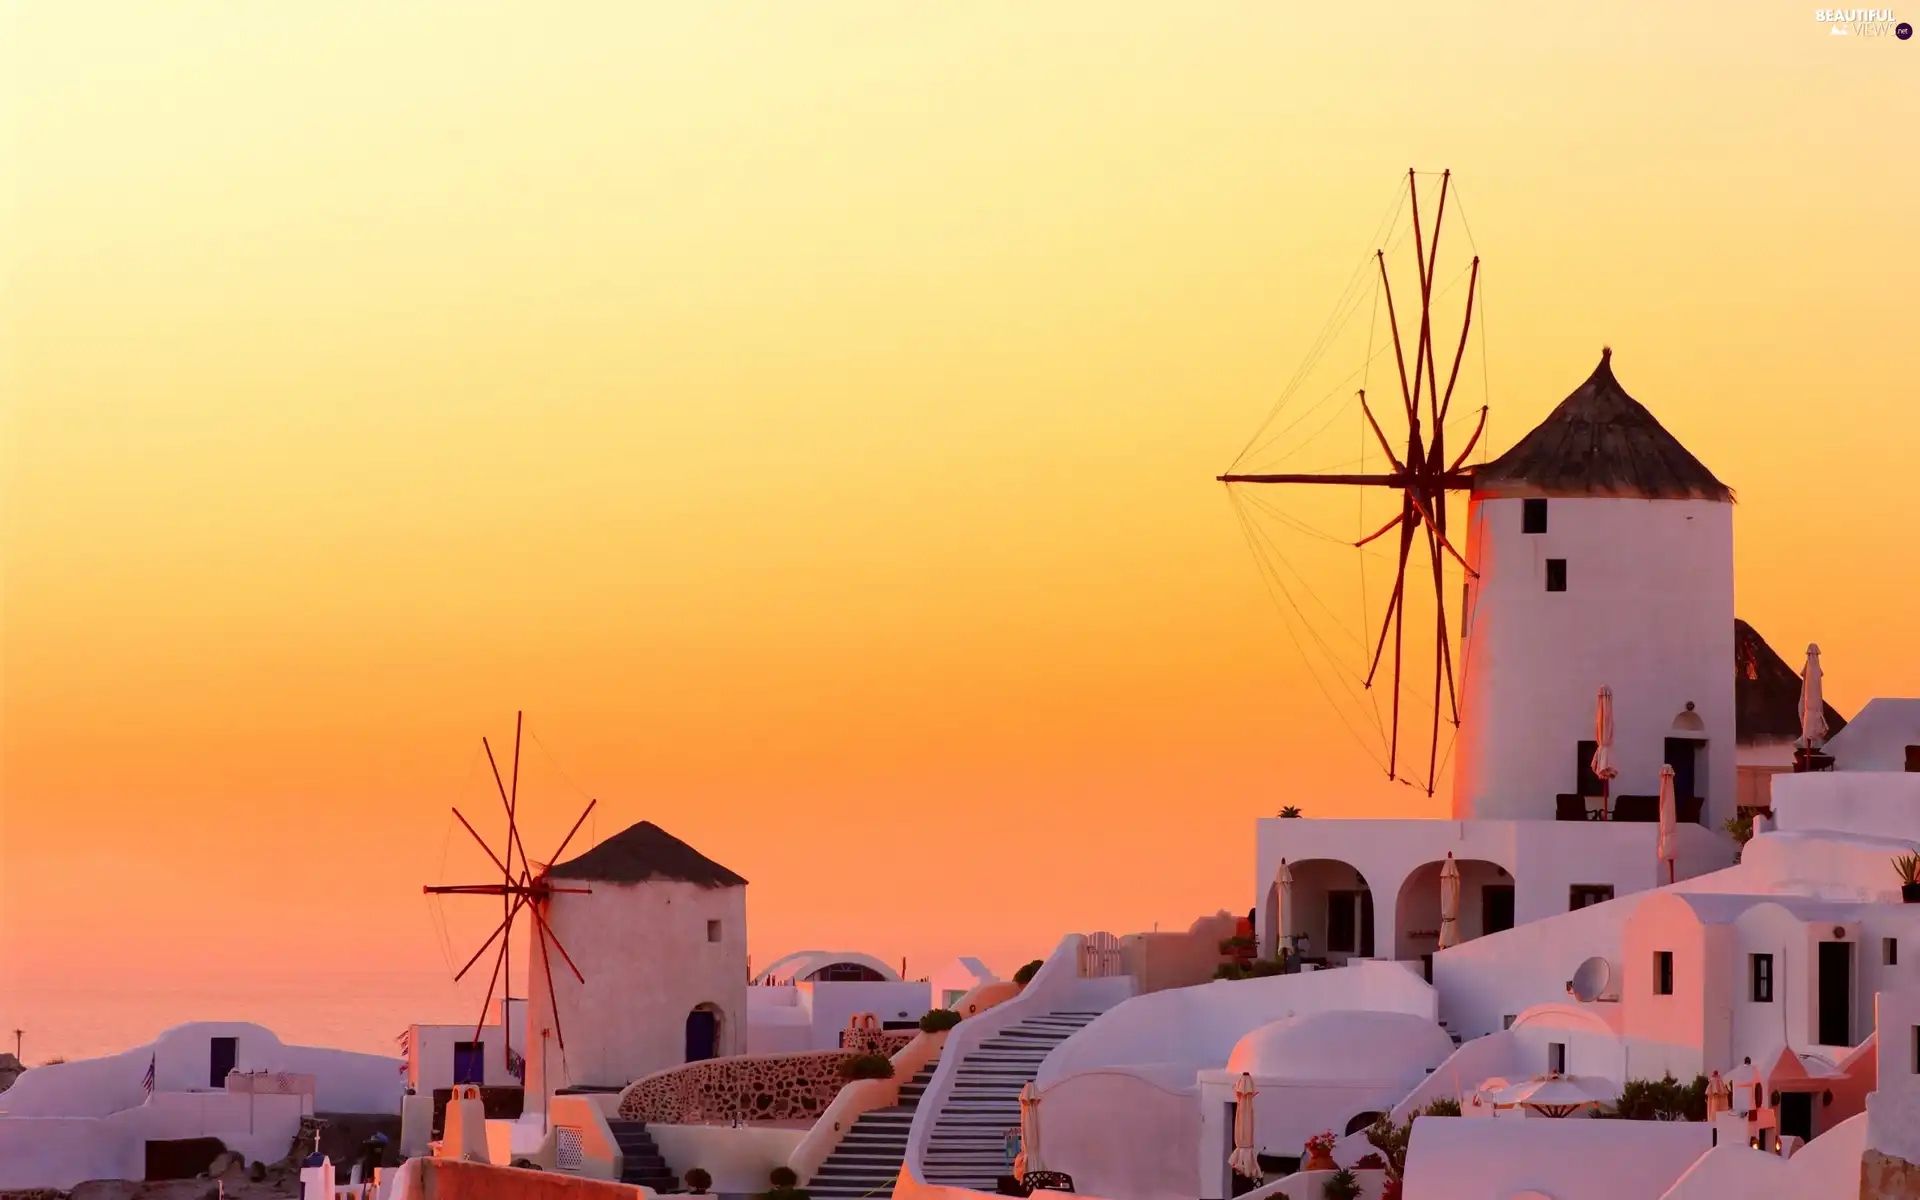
922,1010,1100,1192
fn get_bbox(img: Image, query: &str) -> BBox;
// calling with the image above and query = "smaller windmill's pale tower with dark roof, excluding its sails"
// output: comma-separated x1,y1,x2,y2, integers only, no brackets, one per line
526,822,749,1110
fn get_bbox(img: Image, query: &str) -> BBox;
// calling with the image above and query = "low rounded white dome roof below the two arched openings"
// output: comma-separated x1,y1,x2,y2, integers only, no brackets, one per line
1227,1010,1453,1083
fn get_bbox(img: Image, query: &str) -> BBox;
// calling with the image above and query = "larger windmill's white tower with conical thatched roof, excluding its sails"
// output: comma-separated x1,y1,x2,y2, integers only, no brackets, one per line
1453,351,1736,828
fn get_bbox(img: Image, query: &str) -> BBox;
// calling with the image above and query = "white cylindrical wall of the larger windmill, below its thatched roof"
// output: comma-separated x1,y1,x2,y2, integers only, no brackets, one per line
1453,493,1738,828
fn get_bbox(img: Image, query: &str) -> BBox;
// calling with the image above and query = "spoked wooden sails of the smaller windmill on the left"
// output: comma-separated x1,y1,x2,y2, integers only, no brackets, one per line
424,712,599,1054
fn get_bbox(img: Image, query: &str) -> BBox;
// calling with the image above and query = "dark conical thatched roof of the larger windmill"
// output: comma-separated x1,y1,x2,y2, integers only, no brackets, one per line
1473,349,1734,501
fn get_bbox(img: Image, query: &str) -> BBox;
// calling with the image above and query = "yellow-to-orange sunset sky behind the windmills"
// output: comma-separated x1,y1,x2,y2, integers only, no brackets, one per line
0,0,1920,1058
